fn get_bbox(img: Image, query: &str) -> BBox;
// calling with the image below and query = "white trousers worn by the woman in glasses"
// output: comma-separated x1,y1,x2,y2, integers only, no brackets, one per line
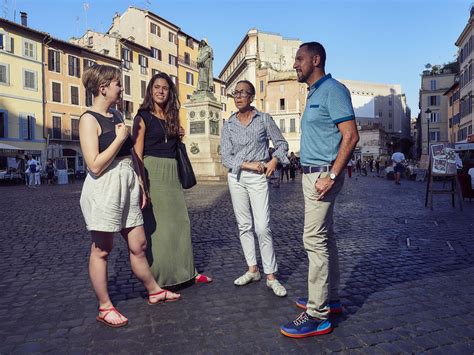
228,171,278,275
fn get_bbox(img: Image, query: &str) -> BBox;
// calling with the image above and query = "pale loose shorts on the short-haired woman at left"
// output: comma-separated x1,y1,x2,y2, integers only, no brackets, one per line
81,157,143,232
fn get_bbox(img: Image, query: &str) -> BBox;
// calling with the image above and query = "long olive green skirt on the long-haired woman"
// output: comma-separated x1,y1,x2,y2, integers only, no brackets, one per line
143,156,197,287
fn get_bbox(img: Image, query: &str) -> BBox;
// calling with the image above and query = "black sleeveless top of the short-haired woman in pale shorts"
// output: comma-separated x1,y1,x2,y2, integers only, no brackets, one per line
84,110,133,158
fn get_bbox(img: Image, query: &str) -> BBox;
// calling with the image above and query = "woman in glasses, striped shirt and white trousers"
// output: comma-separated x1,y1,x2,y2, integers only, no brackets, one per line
221,80,289,296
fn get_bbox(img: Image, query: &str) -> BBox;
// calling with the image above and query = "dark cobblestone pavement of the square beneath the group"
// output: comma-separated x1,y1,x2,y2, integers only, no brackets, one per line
0,177,474,354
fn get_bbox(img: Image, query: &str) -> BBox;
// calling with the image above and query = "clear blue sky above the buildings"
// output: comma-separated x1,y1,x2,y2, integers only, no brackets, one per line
1,0,472,117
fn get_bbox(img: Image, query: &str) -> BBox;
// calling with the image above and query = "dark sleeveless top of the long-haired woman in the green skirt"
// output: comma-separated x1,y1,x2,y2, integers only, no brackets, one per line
137,110,178,159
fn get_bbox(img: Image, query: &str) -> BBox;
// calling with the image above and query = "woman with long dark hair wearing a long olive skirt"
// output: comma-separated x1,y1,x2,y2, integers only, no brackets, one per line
133,73,212,287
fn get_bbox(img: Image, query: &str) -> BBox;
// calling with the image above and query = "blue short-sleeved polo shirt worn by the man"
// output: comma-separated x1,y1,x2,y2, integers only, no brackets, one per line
300,74,355,166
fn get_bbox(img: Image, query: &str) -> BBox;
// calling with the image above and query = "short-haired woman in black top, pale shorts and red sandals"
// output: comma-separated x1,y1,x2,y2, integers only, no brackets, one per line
79,65,180,328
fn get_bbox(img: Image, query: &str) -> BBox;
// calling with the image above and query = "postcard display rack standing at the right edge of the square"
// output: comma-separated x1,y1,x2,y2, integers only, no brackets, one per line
425,144,462,211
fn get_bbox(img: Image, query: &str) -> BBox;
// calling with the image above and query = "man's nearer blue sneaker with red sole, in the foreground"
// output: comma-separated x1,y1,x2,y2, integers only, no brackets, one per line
280,312,332,338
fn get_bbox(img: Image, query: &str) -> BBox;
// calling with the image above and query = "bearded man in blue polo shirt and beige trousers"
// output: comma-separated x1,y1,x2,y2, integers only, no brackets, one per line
281,42,359,338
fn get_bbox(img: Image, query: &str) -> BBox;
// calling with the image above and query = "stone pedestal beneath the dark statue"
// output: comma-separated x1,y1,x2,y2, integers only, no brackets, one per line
183,92,227,182
